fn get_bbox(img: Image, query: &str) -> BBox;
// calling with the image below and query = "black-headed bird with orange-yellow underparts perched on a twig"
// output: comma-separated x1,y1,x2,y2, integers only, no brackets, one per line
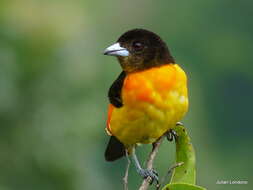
104,29,189,181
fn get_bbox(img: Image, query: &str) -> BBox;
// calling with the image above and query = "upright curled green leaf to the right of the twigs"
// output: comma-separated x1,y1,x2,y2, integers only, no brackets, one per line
170,125,196,184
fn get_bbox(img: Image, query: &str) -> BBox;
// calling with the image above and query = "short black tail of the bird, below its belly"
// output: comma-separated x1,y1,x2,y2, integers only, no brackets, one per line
105,136,126,162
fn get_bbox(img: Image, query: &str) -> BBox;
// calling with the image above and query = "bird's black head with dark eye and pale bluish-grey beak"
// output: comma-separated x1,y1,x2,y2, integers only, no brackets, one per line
105,29,174,72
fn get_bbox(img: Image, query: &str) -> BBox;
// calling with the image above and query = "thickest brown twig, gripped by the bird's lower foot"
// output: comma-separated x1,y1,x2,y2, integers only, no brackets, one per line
139,135,166,190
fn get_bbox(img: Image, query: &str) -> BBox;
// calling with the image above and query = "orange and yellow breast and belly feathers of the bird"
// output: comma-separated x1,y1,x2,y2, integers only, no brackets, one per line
110,64,188,147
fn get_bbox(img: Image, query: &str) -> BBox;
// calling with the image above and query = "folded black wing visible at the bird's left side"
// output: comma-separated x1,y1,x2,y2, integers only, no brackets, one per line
108,71,126,108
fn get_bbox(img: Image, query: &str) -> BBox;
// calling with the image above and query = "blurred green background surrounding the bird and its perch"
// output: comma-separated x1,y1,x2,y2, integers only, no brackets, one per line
0,0,253,190
